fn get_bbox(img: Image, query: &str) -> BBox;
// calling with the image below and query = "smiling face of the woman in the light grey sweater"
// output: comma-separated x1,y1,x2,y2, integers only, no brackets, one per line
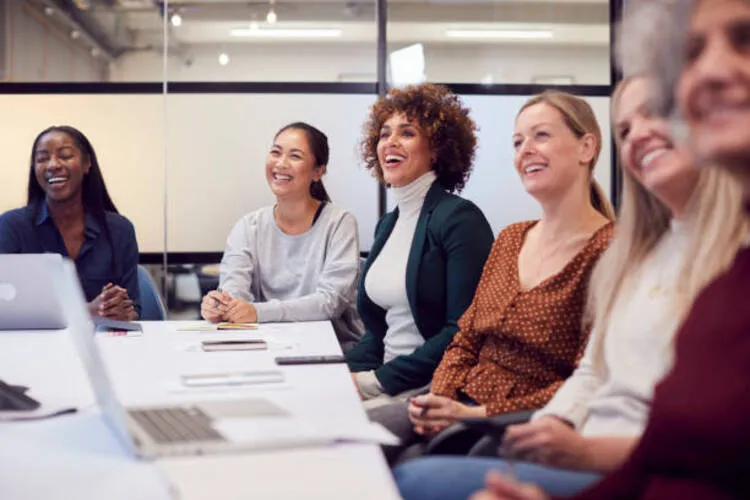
266,128,325,202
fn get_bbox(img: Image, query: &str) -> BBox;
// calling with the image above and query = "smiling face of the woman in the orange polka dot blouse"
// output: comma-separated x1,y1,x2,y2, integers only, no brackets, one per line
513,102,596,201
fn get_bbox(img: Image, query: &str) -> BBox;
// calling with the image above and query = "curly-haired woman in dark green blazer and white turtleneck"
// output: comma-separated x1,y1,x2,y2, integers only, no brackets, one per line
347,84,500,406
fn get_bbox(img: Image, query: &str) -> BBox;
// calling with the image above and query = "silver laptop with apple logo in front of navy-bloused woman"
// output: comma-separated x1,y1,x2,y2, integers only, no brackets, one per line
0,253,67,330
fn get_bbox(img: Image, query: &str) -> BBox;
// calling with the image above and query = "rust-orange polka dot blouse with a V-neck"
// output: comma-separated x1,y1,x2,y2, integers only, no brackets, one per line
431,221,614,416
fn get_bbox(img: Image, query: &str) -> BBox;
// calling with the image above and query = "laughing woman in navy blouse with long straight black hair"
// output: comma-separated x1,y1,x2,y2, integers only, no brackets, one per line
0,126,140,321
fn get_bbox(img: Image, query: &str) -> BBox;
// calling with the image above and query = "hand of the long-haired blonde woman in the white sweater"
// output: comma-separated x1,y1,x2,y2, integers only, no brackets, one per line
503,416,592,470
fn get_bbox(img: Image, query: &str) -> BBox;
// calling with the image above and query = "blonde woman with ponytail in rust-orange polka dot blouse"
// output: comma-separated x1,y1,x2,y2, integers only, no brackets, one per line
370,91,613,462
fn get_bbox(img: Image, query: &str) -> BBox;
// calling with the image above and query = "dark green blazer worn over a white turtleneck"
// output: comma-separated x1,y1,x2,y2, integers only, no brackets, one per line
347,182,494,395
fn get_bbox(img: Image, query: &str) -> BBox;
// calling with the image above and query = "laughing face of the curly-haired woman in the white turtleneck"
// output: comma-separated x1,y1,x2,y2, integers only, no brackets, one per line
377,113,433,187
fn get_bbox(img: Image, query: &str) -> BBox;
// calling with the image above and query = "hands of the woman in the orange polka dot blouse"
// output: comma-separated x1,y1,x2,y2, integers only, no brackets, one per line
408,393,487,436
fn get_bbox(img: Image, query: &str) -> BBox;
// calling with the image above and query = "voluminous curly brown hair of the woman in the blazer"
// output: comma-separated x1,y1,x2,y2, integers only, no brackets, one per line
360,83,478,192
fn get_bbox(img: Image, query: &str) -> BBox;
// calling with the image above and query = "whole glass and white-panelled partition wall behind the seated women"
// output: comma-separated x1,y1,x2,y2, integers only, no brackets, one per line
0,0,611,319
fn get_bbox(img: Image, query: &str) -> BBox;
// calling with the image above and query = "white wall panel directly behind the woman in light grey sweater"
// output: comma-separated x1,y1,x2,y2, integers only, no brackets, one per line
162,94,377,252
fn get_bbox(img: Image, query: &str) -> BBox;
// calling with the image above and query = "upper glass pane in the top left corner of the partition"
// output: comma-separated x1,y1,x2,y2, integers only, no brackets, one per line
0,0,167,83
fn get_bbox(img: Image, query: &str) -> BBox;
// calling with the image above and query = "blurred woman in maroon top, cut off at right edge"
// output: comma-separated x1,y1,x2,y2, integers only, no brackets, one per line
472,0,750,500
